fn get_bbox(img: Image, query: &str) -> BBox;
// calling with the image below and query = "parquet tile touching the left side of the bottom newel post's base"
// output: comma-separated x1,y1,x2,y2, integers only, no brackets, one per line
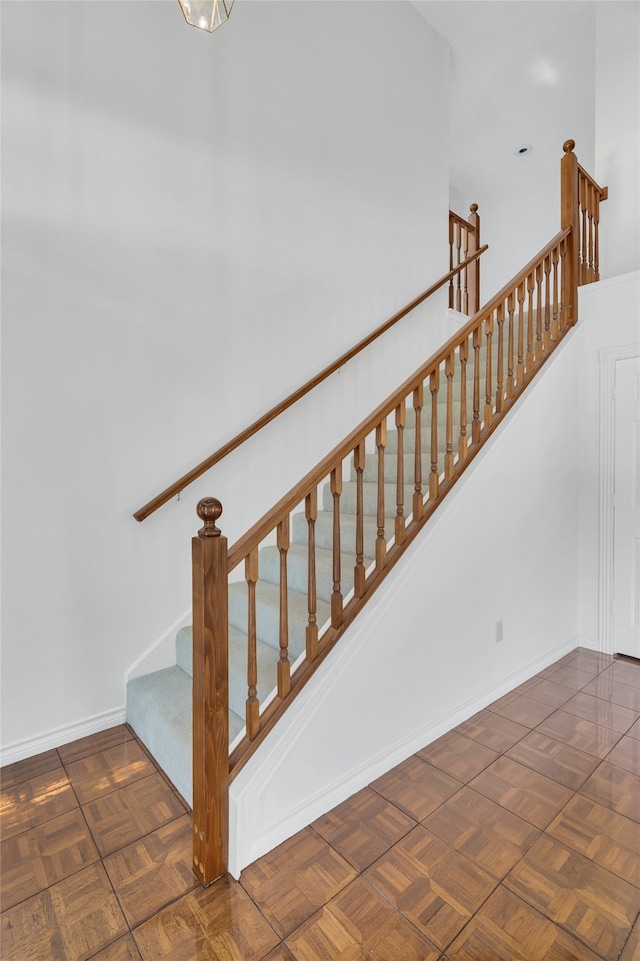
104,815,198,927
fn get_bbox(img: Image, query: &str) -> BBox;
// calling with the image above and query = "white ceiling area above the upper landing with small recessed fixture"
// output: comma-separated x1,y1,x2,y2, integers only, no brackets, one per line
413,0,596,198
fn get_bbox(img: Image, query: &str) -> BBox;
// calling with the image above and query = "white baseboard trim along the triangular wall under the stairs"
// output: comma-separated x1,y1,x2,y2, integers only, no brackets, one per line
229,632,576,879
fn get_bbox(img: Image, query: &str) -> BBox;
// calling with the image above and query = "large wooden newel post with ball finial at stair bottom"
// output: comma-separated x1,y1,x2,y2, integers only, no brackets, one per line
191,497,229,884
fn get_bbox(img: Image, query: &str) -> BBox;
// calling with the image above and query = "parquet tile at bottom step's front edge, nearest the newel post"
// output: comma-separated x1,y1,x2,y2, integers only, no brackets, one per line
83,774,185,857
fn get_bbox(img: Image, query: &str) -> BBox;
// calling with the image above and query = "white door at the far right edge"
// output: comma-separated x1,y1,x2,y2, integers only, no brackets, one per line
613,357,640,658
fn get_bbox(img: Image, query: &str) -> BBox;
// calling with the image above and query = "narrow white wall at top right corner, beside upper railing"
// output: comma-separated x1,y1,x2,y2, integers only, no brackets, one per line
595,0,640,278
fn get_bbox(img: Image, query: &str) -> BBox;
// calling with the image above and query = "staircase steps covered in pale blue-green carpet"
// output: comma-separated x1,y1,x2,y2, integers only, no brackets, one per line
127,360,476,805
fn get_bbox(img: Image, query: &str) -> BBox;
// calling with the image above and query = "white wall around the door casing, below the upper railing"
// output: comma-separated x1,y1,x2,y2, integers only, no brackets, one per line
578,271,640,649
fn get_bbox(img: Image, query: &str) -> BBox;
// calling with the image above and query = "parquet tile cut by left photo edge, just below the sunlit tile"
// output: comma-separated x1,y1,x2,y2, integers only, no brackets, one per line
0,808,99,911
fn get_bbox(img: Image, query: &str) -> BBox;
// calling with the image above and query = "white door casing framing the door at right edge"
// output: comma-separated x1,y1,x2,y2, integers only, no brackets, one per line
598,344,640,654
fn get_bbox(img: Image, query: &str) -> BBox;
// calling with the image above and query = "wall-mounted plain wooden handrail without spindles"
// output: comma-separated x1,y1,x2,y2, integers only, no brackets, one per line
133,244,489,521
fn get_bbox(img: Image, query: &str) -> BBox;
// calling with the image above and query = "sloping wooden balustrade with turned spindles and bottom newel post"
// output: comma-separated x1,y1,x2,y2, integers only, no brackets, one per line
193,141,606,884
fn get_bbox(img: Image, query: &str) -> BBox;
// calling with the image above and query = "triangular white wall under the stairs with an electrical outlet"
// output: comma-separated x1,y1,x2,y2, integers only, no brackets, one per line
230,331,580,876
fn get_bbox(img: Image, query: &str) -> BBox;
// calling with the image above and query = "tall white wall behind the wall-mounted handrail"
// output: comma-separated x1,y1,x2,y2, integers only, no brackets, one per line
1,0,448,760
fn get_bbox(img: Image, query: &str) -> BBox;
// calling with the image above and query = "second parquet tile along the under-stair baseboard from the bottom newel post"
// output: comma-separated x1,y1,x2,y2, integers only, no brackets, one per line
311,788,416,871
